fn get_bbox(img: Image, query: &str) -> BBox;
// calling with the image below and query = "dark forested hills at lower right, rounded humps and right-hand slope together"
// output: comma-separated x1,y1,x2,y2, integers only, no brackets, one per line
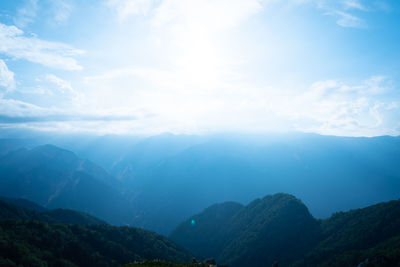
170,193,400,267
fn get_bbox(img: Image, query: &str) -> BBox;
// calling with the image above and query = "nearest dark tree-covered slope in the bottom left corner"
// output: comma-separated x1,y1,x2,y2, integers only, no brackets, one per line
0,220,191,266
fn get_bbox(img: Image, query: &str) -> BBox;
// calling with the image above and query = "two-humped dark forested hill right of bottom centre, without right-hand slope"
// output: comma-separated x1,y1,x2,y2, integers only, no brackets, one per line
170,194,321,266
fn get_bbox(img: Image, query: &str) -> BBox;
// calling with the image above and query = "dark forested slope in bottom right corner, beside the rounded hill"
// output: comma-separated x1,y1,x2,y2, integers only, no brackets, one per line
295,201,400,266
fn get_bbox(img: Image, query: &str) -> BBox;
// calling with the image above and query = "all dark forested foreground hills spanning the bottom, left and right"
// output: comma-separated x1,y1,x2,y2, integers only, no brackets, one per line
0,194,400,267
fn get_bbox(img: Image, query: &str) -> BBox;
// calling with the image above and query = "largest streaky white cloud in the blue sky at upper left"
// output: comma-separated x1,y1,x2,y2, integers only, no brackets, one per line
0,23,84,70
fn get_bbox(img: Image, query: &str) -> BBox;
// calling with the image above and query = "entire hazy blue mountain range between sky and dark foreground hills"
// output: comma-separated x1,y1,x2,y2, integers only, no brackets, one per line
0,134,400,235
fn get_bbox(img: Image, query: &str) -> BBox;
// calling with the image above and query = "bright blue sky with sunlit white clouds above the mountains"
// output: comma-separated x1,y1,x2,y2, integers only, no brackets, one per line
0,0,400,136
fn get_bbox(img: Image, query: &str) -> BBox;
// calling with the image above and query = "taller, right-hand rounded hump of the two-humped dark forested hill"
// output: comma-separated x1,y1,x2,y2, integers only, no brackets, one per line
217,194,320,266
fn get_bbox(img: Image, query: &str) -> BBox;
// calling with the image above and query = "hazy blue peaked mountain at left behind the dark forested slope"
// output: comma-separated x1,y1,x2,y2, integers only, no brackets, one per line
0,145,130,224
